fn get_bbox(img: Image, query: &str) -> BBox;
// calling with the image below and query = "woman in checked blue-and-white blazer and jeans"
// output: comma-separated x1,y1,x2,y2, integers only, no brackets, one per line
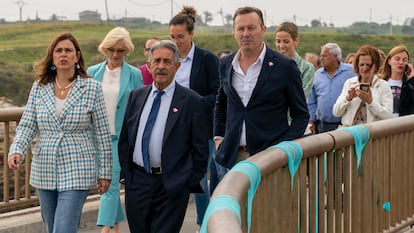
8,32,112,233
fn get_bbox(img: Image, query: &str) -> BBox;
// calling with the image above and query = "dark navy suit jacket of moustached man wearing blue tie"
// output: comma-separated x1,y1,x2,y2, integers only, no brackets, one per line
118,83,209,196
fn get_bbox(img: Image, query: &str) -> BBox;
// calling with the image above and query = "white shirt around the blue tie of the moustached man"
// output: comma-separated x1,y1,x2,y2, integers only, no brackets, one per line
133,82,175,167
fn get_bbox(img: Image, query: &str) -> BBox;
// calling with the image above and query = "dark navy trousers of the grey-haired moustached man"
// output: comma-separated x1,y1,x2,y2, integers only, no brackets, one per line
125,168,189,233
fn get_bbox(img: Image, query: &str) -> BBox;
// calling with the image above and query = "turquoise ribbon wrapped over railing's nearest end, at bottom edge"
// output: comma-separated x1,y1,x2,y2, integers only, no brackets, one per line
200,195,241,233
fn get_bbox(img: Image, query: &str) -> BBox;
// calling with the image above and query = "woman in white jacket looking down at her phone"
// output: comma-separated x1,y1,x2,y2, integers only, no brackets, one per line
333,45,393,126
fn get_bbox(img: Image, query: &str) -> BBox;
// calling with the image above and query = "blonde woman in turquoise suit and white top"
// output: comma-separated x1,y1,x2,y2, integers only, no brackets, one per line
88,27,142,233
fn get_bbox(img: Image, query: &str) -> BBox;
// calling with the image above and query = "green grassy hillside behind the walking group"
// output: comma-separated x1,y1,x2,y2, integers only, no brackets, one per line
0,22,414,105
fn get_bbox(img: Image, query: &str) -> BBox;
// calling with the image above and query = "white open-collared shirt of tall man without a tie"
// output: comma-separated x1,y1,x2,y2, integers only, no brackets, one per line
231,46,266,146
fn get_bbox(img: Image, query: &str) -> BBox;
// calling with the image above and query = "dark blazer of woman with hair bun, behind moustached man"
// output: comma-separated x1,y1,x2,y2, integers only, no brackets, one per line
190,46,219,138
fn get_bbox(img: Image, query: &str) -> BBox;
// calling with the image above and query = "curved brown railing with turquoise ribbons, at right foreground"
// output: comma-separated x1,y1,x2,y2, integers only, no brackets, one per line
204,116,414,233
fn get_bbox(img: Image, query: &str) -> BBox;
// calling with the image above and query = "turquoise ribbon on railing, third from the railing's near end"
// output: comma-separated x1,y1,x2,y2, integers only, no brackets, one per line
268,141,303,190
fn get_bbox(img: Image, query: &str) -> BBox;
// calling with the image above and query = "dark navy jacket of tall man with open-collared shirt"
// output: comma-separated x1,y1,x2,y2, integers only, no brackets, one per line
214,47,309,168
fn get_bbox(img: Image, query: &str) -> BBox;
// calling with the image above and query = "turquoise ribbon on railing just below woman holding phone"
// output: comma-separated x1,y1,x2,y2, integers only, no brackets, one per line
339,125,371,174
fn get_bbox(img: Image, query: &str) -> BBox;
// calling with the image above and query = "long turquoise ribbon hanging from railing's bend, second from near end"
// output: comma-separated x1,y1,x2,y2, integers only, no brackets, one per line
230,160,262,233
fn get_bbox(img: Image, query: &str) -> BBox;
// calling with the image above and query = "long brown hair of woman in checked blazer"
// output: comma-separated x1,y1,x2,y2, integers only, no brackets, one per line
33,32,90,85
